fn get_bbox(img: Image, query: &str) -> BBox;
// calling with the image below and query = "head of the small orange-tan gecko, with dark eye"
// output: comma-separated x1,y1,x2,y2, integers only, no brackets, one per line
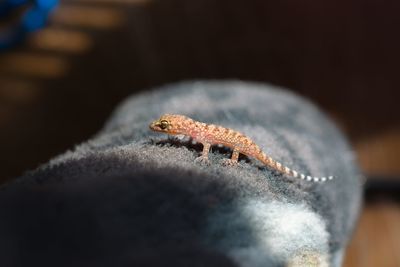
149,114,187,134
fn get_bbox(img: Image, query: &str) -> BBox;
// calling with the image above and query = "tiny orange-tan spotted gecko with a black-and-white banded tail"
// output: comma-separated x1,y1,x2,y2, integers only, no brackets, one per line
149,114,334,182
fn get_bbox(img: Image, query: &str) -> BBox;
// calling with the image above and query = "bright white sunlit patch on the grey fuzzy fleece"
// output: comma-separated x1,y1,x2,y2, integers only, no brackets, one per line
231,200,328,267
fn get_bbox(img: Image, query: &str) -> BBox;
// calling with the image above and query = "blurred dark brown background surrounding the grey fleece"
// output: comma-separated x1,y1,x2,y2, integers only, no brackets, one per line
0,0,400,267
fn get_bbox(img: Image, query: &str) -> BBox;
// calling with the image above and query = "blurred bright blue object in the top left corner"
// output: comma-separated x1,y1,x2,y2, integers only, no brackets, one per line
0,0,58,50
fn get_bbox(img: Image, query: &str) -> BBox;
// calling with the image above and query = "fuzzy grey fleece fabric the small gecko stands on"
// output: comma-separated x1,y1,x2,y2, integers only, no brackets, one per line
0,81,361,267
